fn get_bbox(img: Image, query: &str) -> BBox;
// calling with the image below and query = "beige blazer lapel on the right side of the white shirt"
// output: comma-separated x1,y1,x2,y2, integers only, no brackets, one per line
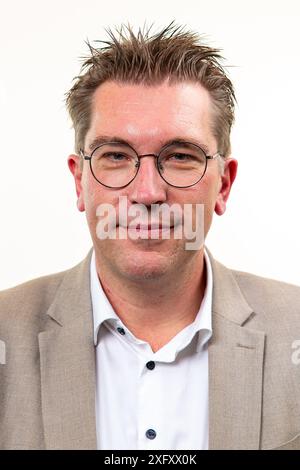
208,258,265,450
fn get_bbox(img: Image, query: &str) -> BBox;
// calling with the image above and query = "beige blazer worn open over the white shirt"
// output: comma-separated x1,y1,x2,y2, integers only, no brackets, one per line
0,251,300,449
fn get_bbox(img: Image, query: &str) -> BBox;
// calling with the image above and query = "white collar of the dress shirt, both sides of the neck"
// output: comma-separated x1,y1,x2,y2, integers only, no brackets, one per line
90,249,213,354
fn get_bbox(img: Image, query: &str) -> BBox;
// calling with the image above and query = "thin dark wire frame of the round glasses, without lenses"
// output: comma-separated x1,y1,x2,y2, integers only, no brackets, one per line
79,141,223,189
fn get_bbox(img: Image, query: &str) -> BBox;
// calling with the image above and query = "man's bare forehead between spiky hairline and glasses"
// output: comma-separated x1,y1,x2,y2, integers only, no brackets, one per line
86,82,214,149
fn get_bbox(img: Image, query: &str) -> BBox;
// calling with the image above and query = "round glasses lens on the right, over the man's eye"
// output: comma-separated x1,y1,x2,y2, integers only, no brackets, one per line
158,142,206,187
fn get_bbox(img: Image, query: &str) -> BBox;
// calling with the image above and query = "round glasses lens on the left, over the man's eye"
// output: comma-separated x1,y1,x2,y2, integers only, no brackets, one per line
91,143,138,188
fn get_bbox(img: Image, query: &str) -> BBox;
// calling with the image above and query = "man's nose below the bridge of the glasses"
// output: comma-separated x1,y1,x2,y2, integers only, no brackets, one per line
128,155,168,206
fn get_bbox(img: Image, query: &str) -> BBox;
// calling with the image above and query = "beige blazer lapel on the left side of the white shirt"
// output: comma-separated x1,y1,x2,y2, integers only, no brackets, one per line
39,251,97,449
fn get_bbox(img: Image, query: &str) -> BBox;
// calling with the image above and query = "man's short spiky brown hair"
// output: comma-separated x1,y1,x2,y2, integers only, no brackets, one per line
66,22,235,157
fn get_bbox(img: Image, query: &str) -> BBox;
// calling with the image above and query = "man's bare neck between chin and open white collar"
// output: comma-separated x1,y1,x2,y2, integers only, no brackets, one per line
96,251,206,352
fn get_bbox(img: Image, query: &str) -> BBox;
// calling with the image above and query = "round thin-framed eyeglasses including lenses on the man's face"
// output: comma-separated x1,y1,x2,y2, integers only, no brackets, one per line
80,142,222,189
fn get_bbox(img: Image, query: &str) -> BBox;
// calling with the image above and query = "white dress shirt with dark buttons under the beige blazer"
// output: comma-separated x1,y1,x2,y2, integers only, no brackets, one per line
90,253,213,450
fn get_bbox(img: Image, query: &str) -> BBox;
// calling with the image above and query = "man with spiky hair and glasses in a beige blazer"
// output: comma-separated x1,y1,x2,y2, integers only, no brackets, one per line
0,24,300,450
